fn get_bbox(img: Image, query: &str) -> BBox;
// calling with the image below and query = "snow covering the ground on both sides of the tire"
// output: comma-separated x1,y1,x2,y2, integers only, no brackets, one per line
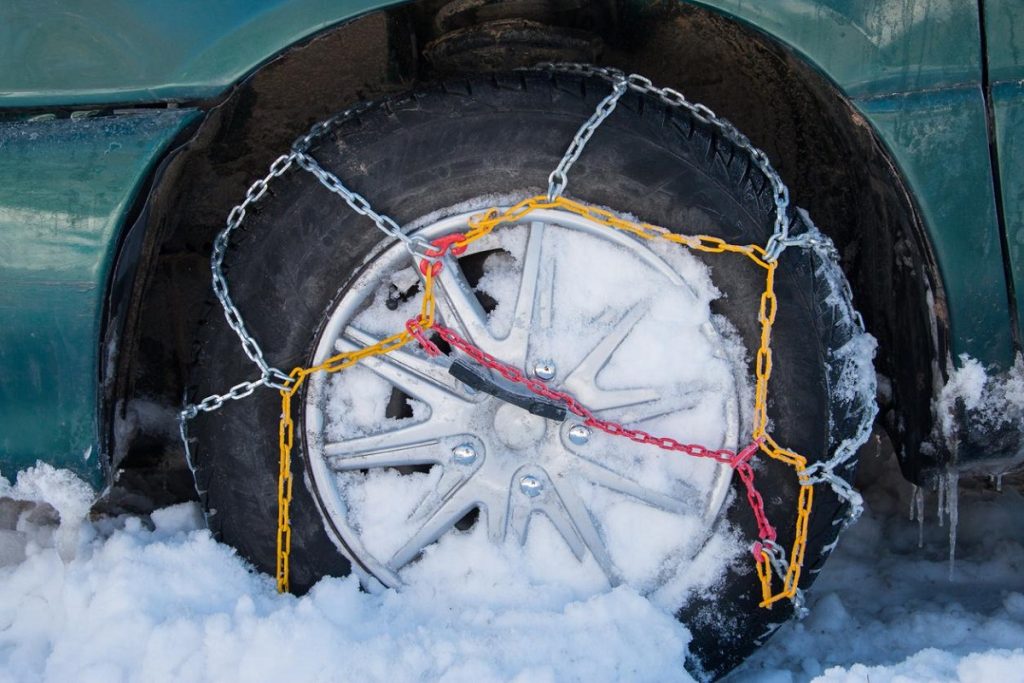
0,446,1024,683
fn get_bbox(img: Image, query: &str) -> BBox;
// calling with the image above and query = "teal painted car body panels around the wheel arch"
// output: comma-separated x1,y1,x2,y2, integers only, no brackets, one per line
0,0,1024,488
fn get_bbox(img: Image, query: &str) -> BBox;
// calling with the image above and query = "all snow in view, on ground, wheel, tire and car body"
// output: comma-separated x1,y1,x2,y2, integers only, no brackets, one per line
0,209,1024,683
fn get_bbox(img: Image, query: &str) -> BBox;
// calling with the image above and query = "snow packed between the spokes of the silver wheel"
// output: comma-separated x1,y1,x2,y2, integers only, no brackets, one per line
310,207,749,612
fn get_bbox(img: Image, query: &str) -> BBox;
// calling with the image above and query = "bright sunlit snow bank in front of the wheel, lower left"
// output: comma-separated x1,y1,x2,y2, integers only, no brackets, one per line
0,485,689,683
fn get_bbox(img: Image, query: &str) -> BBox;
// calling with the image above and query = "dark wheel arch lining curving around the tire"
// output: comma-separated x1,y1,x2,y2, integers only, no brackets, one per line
105,2,949,493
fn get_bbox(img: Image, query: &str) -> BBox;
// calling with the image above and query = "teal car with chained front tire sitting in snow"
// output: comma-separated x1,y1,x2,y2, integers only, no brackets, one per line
0,0,1024,678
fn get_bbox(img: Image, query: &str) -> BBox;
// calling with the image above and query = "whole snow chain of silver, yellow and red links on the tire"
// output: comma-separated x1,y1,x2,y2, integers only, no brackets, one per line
180,65,863,607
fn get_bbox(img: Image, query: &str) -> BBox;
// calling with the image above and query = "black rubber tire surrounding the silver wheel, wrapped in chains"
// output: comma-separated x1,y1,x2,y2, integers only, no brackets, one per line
193,73,859,677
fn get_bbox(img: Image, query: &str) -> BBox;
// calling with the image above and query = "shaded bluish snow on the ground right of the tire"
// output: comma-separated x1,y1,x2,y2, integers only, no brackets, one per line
730,440,1024,683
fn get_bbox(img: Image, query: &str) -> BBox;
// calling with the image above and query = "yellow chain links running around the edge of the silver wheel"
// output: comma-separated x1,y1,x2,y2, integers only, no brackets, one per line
276,196,814,607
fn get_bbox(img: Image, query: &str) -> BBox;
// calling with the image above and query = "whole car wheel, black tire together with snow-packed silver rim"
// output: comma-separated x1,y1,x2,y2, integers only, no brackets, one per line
193,72,873,677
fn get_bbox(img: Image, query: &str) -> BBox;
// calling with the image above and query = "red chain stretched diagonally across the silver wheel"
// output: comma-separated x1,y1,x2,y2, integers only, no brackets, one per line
406,318,777,562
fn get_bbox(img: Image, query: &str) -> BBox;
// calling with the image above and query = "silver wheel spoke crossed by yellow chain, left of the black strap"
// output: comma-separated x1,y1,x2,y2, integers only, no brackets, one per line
335,326,473,408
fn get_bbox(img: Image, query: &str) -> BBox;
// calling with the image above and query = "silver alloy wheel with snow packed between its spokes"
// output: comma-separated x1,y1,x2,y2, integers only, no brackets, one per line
305,204,745,591
